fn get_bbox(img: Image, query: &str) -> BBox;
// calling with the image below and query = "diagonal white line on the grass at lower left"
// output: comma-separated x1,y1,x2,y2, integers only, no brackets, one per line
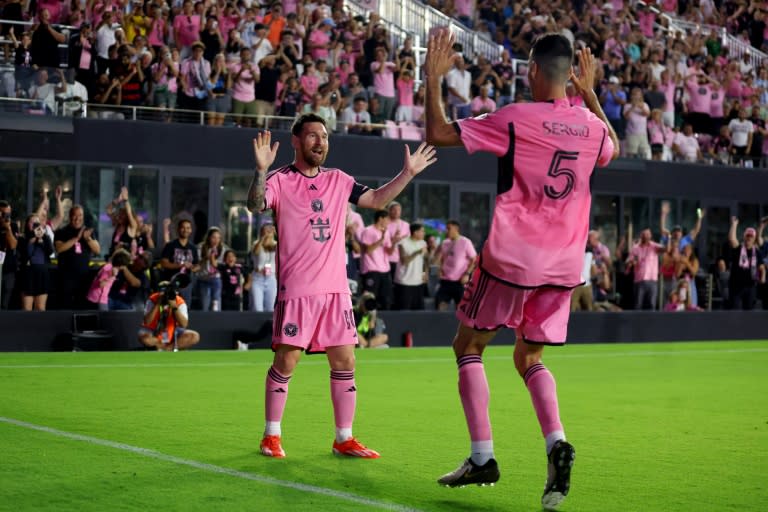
0,416,421,512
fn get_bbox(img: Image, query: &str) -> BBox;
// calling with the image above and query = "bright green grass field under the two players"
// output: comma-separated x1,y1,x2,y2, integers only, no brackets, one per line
0,341,768,512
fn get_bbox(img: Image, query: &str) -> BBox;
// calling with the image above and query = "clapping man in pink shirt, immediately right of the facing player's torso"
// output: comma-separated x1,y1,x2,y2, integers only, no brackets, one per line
360,210,395,309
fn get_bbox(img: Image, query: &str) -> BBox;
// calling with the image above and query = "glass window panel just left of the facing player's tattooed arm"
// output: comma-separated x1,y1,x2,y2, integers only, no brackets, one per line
221,174,260,261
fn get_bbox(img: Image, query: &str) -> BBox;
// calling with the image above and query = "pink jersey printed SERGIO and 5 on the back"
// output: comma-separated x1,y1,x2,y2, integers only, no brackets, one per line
457,98,613,287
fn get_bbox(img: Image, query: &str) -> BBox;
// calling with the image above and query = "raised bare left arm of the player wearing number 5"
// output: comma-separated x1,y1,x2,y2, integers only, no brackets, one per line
424,28,462,146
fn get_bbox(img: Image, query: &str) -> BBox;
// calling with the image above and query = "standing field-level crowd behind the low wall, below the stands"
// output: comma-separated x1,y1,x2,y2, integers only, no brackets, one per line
0,188,768,311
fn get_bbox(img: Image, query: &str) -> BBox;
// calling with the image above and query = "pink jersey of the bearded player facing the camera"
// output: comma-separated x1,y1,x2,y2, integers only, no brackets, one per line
265,165,368,300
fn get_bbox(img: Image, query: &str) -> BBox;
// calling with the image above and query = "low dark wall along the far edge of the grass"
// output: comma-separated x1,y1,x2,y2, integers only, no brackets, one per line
0,311,768,353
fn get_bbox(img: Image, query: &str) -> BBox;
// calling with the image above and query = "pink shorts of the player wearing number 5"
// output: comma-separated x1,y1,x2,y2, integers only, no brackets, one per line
456,268,572,345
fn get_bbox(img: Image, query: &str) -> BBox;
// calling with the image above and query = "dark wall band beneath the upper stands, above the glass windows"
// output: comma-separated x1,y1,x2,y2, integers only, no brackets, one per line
0,116,768,204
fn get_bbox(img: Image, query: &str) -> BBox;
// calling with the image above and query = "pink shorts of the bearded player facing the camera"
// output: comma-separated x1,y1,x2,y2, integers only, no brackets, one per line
272,293,357,354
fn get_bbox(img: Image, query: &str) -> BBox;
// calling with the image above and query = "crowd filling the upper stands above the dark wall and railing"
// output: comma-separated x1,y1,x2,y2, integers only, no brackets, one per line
0,0,768,163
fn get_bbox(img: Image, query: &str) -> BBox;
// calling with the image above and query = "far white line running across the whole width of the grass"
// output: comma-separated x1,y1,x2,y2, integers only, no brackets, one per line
0,346,768,370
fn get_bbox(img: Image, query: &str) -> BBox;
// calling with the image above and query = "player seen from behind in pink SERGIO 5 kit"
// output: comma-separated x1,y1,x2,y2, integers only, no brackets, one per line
425,29,619,509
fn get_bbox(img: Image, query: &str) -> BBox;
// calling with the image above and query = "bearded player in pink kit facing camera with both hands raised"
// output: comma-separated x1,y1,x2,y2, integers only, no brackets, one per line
247,113,436,459
